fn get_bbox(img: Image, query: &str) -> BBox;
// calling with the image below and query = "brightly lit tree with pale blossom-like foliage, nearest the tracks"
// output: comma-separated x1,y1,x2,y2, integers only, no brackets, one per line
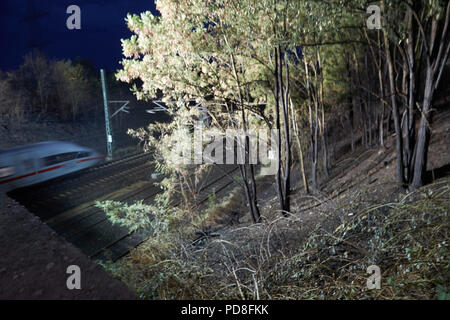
117,1,270,222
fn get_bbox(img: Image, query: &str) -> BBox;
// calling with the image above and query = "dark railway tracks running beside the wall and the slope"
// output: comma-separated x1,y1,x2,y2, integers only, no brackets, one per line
10,153,237,261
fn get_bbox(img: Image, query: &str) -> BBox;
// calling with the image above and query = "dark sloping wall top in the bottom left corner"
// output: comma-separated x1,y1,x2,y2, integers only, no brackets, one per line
0,195,137,300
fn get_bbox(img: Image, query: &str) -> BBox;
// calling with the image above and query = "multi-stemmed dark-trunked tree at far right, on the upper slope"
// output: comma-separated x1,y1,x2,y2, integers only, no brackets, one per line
381,0,450,189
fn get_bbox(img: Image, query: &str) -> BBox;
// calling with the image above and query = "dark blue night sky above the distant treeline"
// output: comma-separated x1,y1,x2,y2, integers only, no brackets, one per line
0,0,157,71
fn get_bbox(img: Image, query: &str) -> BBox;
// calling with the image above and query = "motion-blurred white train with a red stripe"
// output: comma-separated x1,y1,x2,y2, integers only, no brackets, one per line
0,141,104,192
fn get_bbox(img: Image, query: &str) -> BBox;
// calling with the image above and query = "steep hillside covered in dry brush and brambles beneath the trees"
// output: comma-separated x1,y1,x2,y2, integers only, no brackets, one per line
106,113,450,299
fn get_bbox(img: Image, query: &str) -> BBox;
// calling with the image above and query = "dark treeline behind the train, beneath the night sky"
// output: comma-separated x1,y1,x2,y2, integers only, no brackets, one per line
0,51,142,124
